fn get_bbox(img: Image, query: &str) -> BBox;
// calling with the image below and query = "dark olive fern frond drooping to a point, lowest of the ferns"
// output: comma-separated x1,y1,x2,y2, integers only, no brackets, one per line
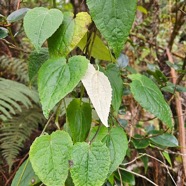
0,106,45,170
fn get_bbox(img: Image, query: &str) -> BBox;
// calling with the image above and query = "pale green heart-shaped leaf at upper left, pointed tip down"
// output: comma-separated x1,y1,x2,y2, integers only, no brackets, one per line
24,7,63,51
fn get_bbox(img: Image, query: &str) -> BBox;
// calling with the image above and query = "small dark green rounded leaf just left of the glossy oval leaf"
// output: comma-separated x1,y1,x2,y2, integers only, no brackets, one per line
132,134,150,149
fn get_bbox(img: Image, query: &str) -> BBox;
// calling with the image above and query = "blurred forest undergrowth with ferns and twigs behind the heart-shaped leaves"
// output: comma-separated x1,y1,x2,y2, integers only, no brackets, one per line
0,0,186,186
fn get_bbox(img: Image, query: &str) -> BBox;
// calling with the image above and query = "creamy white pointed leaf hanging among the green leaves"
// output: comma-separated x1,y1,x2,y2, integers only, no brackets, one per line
82,64,112,127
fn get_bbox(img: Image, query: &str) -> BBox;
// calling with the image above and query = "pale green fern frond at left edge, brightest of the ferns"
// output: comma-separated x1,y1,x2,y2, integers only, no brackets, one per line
0,78,39,121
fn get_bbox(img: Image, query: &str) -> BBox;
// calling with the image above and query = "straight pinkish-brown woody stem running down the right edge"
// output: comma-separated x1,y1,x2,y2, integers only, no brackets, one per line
167,49,186,176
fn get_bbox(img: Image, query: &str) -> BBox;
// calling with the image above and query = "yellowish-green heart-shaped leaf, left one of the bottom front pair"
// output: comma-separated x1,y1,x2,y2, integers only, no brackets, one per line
29,131,73,186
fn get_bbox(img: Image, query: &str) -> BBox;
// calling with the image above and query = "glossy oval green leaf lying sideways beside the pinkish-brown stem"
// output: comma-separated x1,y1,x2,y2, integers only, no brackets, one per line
150,133,178,147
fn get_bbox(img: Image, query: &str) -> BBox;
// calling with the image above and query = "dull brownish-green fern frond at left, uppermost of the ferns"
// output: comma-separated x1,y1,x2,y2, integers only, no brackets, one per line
0,55,29,83
